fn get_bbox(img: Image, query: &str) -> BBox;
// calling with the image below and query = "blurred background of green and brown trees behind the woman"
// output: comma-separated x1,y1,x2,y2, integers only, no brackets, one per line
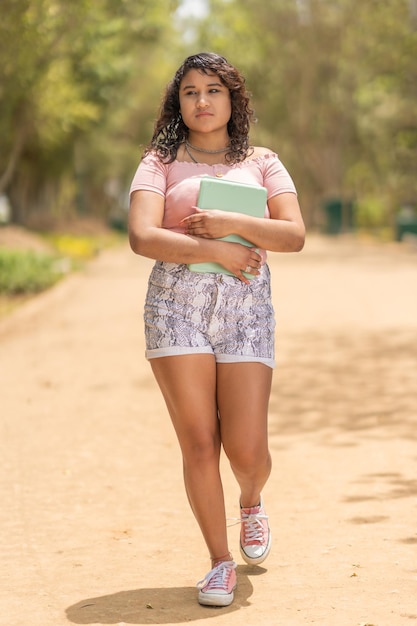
0,0,417,240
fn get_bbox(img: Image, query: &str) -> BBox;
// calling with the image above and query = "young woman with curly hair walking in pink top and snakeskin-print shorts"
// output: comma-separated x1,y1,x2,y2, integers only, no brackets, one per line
129,53,305,606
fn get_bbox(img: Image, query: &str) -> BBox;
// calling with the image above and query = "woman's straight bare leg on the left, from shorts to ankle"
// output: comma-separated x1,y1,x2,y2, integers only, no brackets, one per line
151,354,229,560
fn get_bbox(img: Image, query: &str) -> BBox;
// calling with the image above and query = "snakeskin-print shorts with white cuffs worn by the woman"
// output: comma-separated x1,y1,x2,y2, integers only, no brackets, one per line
144,261,275,368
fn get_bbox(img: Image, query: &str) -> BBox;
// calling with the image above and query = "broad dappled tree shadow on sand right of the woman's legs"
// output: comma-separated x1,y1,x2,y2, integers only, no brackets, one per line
270,330,417,438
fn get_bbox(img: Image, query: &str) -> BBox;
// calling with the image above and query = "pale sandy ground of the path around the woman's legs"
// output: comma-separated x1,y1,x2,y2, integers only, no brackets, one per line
0,236,417,626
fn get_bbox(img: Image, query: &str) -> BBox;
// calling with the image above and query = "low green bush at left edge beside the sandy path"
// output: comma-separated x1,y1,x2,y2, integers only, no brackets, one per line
0,249,70,295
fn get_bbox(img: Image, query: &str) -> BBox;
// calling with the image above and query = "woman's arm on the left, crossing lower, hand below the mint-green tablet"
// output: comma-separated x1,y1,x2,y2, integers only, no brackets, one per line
128,191,261,282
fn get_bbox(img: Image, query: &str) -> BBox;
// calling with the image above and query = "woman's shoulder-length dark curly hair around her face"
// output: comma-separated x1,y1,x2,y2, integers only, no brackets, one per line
144,52,255,163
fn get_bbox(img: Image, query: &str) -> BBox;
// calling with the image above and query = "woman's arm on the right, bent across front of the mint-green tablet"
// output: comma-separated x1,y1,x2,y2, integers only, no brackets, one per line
183,193,305,252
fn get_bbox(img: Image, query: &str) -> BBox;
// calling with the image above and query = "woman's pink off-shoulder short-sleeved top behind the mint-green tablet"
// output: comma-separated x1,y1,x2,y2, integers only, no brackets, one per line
130,152,296,233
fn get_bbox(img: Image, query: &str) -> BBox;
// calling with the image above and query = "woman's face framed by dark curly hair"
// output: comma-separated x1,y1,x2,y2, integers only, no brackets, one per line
179,69,232,133
